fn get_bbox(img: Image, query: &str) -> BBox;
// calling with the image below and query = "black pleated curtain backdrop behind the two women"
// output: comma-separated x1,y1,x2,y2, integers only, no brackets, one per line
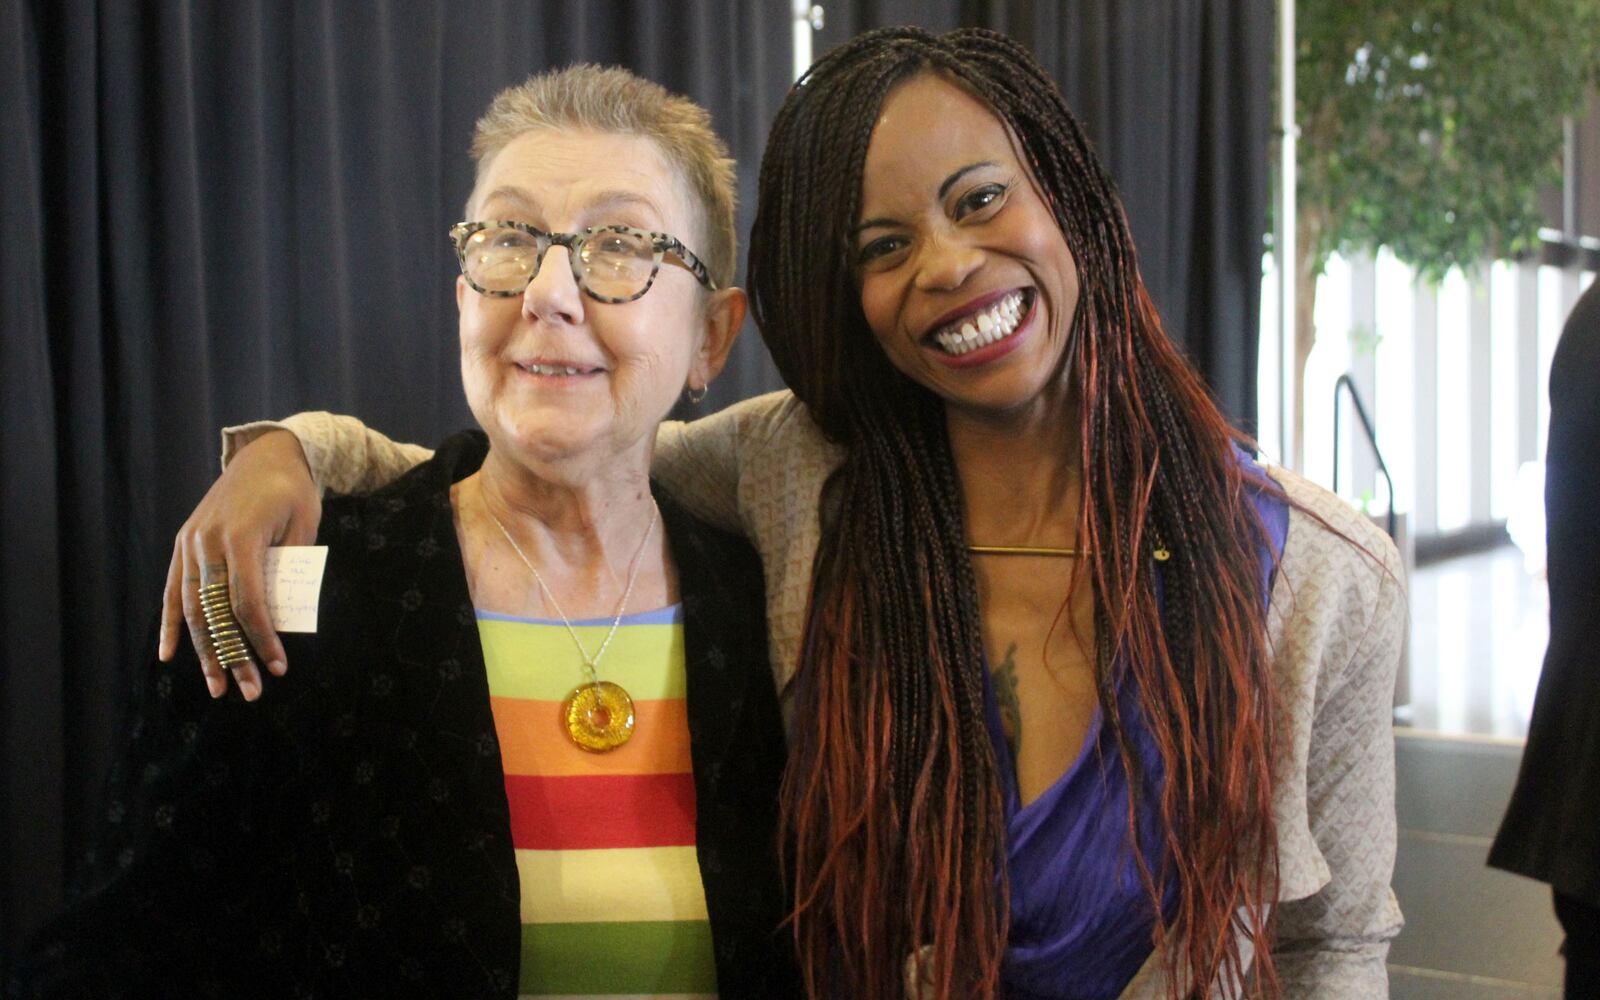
0,0,1274,966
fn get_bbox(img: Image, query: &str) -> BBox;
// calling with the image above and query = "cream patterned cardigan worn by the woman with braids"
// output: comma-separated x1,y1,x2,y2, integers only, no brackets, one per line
222,392,1406,1000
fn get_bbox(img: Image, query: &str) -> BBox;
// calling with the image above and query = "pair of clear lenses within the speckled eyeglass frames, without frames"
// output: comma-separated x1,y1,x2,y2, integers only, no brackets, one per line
462,227,656,299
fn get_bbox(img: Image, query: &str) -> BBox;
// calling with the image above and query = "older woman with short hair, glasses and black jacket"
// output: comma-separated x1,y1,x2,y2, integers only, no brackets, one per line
22,67,798,997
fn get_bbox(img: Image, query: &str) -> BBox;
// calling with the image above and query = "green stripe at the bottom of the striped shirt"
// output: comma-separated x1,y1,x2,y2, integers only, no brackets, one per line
518,920,717,994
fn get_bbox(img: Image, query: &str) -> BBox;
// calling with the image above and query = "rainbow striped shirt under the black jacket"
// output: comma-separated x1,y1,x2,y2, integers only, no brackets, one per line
477,606,717,1000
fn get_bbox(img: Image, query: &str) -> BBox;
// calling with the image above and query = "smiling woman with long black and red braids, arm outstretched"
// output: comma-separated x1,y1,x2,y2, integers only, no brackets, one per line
159,29,1403,998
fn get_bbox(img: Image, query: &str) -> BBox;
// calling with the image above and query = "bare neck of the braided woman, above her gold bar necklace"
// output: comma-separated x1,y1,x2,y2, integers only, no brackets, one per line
946,395,1082,549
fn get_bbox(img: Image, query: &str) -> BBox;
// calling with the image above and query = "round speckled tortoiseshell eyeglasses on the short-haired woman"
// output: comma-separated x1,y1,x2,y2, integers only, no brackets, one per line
450,222,717,302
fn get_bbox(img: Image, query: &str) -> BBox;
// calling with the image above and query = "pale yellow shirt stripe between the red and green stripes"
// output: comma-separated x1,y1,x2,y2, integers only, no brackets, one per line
517,846,707,923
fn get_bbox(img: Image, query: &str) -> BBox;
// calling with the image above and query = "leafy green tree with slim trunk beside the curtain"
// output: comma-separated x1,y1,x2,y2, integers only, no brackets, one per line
1294,0,1600,454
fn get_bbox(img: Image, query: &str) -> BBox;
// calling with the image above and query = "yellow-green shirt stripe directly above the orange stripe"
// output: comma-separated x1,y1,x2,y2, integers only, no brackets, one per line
478,618,685,701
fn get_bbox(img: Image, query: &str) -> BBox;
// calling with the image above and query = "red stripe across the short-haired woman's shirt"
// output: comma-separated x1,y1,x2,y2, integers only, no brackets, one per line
506,774,694,851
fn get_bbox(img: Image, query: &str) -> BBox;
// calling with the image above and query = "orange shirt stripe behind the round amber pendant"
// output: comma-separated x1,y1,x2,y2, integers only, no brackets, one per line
490,698,693,778
